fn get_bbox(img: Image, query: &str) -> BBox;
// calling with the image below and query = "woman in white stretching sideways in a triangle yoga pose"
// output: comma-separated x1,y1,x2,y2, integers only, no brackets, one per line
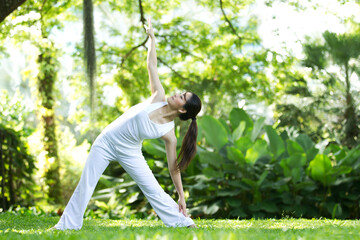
53,18,201,230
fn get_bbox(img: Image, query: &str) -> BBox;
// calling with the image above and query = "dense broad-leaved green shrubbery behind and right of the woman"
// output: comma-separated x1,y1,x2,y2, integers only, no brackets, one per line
93,109,360,218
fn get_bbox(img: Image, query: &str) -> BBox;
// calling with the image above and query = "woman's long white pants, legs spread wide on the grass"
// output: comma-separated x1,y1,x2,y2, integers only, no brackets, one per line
55,135,194,230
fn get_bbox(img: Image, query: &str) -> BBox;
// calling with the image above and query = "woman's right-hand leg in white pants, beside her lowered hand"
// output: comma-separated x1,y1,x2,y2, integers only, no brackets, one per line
118,156,194,227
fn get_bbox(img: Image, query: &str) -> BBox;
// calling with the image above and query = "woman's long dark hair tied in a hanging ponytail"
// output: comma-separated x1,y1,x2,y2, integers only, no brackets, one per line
177,93,201,170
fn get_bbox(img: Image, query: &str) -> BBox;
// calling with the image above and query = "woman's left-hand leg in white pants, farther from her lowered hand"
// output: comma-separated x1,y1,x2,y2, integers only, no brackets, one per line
54,136,114,230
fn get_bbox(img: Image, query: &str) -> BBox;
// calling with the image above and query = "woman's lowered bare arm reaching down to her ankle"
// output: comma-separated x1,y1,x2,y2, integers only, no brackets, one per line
162,131,187,216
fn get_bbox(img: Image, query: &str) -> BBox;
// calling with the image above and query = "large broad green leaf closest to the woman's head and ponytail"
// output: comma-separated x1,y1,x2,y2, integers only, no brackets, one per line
200,116,228,150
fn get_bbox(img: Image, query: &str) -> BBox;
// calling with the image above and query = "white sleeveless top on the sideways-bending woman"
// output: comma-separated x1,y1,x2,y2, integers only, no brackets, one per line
102,101,175,157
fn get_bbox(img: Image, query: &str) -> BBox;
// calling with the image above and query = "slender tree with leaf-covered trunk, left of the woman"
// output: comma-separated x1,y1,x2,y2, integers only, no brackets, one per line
1,0,71,203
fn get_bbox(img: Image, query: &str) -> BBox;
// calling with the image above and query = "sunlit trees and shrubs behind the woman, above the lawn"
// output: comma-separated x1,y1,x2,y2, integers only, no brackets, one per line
0,0,360,222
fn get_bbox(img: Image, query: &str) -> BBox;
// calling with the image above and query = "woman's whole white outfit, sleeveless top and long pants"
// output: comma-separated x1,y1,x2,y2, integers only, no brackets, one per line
55,102,194,230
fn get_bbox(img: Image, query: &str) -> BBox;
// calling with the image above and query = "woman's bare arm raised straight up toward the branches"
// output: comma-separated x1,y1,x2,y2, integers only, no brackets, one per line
144,17,165,101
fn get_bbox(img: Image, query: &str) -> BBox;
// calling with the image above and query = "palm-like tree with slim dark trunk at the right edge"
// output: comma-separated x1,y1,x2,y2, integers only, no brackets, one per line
303,31,360,147
